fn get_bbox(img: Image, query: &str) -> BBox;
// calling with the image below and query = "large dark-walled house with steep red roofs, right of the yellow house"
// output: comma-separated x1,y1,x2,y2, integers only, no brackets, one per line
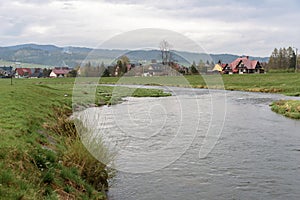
224,56,264,74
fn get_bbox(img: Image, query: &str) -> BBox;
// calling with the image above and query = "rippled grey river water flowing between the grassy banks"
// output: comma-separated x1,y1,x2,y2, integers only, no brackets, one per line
76,88,300,200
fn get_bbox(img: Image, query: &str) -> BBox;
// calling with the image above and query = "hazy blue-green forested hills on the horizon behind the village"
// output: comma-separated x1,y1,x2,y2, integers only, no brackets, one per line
0,43,269,67
